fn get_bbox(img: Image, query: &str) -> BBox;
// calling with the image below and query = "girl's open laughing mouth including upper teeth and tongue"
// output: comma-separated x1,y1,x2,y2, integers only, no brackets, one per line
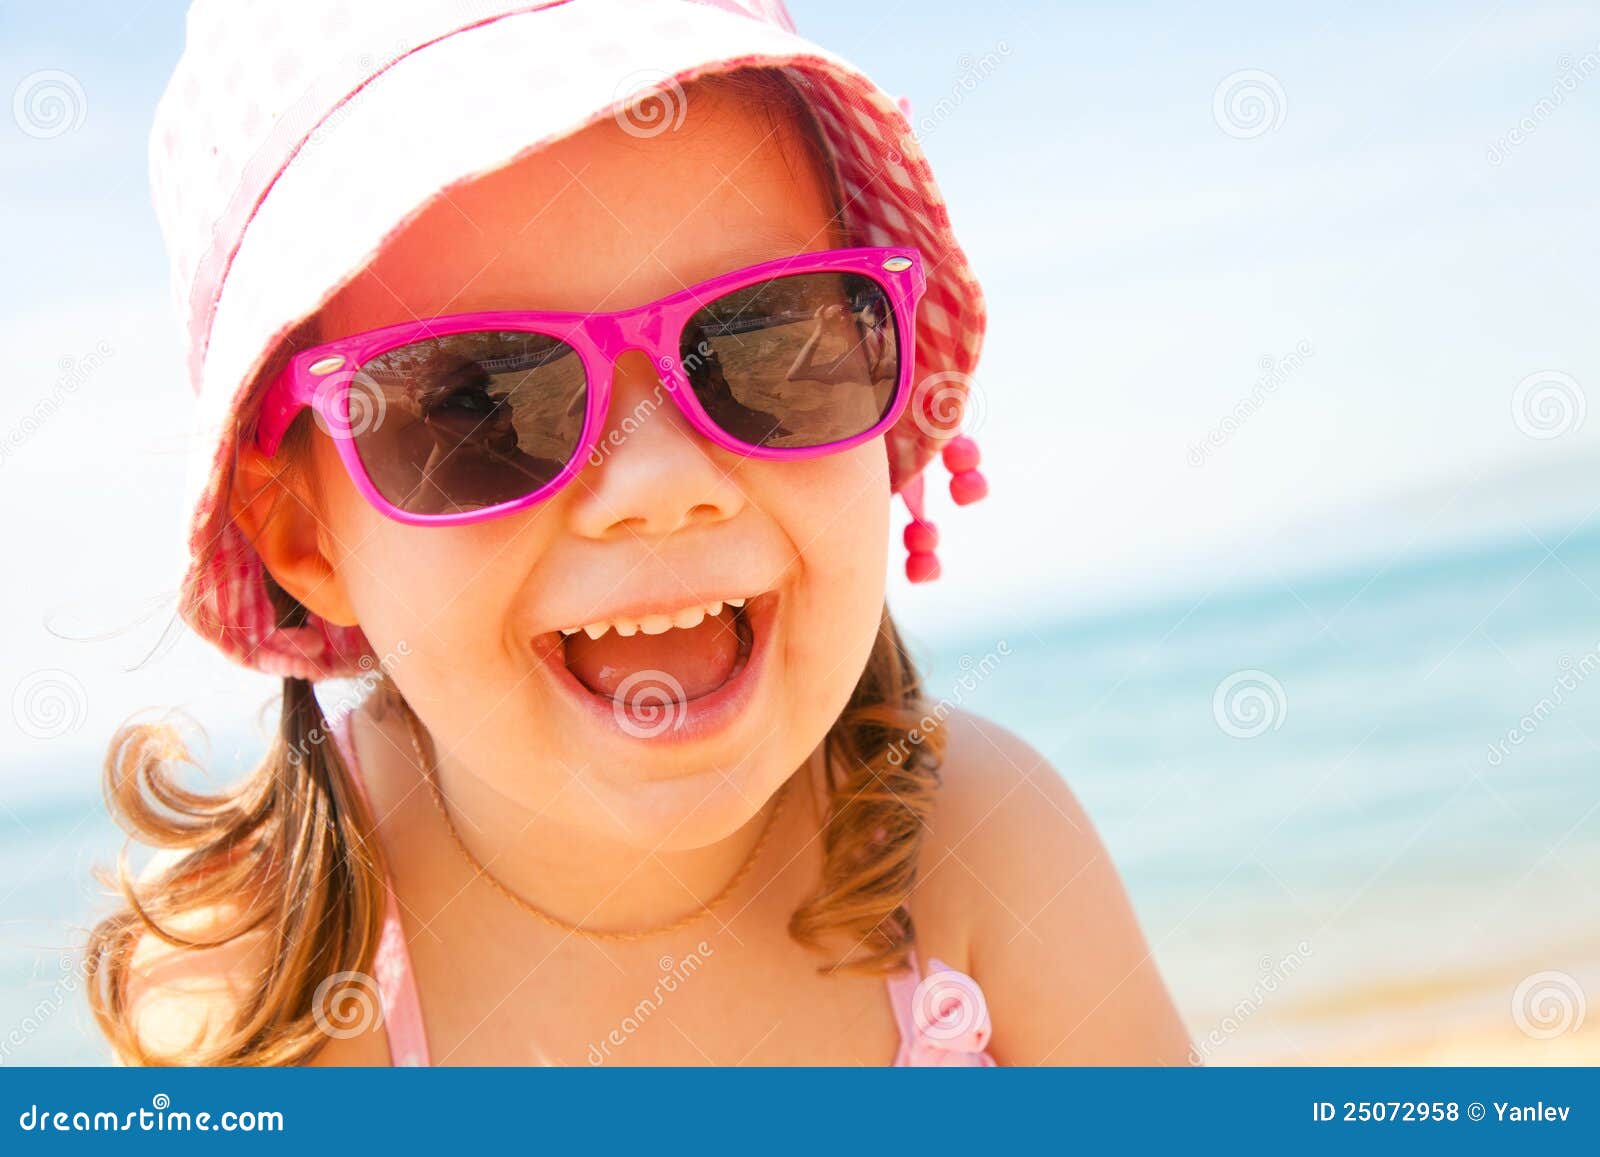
552,592,776,720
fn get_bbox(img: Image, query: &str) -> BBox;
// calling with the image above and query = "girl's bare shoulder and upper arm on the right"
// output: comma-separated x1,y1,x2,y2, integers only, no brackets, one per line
918,711,1190,1064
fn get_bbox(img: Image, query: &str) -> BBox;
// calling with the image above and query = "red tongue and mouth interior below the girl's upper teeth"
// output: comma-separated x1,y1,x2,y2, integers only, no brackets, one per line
566,608,739,706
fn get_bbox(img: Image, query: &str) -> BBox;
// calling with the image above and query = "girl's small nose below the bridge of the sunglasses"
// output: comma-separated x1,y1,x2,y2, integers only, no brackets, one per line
568,349,746,539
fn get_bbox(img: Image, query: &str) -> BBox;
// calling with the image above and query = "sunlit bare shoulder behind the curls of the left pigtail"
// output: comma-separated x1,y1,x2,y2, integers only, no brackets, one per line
122,853,389,1064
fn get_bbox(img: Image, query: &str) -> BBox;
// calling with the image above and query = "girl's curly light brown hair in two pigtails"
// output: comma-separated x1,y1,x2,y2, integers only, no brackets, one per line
86,69,944,1066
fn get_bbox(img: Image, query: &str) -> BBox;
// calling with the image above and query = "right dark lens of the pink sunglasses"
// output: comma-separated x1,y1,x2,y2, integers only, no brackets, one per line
678,274,901,450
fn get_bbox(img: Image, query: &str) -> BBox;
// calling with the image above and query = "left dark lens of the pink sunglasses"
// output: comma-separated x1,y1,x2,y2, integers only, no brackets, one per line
346,331,589,514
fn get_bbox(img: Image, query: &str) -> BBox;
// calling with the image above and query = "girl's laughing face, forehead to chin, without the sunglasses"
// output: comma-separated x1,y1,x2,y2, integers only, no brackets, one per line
297,79,890,848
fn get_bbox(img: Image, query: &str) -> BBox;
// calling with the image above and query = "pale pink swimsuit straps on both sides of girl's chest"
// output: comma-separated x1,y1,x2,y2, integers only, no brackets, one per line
331,714,995,1067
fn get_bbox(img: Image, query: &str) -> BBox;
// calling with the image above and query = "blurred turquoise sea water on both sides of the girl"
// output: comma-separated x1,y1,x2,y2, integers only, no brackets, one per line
0,534,1600,1064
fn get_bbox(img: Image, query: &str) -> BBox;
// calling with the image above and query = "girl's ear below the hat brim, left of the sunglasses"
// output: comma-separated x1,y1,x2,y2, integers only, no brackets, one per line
232,443,355,627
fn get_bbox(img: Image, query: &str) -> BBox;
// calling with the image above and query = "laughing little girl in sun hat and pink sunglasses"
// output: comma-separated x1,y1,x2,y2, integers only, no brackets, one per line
90,0,1189,1066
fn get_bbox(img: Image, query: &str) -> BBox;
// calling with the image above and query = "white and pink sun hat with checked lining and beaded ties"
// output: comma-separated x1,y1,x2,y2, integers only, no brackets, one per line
150,0,984,680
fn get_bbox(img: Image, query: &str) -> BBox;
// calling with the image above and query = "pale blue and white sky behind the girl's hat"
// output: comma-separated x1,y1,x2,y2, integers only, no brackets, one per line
0,0,1600,791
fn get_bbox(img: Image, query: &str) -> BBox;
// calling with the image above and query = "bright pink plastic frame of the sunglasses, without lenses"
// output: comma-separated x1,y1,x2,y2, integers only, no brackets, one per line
256,246,926,526
